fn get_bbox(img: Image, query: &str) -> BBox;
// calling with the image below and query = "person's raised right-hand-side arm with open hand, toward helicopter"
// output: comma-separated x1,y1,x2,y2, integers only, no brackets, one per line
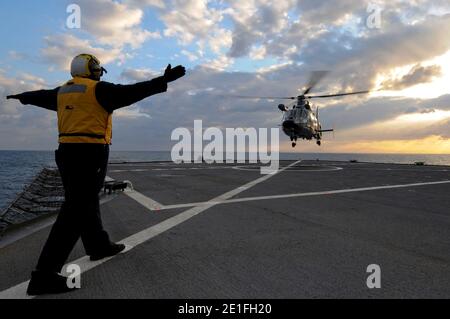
95,64,186,113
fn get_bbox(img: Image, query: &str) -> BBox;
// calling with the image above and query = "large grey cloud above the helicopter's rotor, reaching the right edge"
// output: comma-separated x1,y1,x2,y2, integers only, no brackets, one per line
284,15,450,88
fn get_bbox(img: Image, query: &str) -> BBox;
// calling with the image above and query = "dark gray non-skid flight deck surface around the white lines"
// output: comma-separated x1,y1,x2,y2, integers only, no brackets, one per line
0,161,450,298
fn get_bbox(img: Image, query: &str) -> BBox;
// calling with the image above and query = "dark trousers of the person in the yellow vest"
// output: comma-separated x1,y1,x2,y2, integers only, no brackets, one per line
36,144,111,272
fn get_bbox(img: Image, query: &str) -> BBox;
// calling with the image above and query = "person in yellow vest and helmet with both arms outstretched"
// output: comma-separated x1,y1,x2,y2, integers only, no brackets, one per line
7,54,186,295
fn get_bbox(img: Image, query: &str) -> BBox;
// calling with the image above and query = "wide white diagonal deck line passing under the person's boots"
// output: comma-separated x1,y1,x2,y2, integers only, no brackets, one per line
0,161,300,299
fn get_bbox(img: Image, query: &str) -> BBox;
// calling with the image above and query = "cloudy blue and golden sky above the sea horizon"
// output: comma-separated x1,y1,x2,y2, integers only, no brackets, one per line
0,0,450,154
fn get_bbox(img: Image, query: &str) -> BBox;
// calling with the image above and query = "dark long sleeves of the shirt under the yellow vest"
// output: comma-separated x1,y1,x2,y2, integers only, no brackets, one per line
14,77,167,113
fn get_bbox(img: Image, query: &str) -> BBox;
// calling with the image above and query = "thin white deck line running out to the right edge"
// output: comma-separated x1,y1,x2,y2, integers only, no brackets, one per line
141,180,450,210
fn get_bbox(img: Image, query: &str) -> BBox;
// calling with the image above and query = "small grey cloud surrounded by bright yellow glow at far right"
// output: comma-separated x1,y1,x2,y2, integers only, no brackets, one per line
381,64,442,90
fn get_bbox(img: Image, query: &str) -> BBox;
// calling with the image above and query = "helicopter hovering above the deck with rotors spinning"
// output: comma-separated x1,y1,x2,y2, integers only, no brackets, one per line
232,71,370,147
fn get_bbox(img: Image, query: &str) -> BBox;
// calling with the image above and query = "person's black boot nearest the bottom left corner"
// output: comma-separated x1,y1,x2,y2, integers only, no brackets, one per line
27,270,77,296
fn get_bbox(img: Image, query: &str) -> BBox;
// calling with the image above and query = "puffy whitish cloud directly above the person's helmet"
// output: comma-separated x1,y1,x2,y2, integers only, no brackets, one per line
41,0,161,70
